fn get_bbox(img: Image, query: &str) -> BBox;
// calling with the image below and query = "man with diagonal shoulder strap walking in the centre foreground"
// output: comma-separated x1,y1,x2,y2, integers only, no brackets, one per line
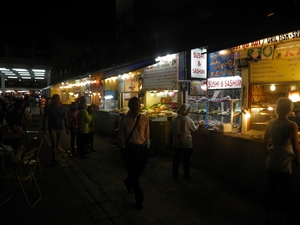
119,97,150,209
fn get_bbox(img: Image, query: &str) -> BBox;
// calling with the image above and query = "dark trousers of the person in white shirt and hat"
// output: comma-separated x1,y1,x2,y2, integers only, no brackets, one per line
172,147,193,177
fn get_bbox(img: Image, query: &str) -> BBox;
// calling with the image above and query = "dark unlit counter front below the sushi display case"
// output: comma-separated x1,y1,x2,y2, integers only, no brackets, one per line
192,129,300,195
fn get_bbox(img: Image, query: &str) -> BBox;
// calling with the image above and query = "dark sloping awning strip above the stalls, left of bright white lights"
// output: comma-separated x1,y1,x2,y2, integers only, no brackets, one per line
103,59,157,79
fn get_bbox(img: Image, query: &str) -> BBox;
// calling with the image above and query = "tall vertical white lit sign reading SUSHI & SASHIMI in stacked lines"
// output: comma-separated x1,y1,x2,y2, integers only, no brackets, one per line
191,48,207,79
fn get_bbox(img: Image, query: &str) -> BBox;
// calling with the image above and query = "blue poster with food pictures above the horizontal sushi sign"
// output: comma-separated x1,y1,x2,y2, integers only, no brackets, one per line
208,49,235,77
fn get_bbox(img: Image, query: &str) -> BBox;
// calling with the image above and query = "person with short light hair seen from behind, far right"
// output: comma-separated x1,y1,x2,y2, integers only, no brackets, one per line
263,97,300,224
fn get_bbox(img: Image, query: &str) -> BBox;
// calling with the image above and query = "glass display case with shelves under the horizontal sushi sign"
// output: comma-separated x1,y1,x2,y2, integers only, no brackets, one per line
206,97,242,132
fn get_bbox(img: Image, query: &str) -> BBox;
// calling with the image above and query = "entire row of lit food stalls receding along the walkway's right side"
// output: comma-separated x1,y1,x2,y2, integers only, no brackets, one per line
51,30,300,193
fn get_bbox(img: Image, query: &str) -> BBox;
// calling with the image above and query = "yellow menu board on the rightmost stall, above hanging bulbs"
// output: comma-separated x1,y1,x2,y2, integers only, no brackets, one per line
250,47,300,83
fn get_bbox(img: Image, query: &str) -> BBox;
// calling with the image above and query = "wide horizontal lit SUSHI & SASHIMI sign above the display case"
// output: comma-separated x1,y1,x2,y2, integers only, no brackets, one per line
207,76,242,90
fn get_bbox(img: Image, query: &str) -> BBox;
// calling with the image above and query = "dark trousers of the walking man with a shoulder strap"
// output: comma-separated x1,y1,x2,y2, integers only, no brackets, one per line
124,145,147,203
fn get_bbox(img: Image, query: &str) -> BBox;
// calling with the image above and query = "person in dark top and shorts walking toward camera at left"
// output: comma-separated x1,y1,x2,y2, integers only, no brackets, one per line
43,94,69,163
